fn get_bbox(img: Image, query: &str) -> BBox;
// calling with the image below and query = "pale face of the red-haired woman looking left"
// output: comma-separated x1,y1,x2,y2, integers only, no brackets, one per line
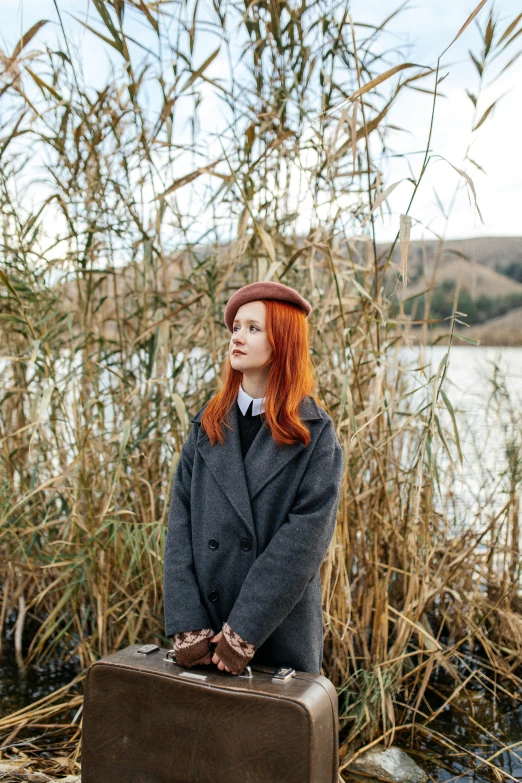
230,300,272,374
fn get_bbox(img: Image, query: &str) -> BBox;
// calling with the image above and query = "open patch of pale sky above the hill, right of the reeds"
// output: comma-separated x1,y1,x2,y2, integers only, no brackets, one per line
360,0,522,238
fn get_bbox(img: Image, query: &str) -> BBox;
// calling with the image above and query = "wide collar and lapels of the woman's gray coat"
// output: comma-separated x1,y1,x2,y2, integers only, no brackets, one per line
191,397,323,540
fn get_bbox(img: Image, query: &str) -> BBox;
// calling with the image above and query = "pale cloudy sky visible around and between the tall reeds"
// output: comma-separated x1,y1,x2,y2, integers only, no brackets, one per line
0,0,522,245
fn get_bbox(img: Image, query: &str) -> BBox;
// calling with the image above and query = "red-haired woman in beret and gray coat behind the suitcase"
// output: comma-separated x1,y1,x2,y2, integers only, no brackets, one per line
164,282,344,674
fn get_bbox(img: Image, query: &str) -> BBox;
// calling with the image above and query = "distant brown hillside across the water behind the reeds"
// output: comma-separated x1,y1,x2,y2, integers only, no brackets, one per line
51,237,522,345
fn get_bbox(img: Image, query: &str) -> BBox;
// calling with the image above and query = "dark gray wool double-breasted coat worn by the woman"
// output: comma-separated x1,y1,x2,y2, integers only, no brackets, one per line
163,397,344,674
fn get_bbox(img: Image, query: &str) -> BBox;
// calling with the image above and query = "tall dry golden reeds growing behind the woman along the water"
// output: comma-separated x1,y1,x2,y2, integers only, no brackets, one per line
0,0,522,772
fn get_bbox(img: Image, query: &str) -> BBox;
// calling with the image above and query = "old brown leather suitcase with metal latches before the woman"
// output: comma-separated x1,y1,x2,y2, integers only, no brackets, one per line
81,644,339,783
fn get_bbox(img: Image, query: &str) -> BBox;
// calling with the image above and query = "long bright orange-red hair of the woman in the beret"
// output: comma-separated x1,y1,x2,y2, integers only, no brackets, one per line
201,299,326,447
